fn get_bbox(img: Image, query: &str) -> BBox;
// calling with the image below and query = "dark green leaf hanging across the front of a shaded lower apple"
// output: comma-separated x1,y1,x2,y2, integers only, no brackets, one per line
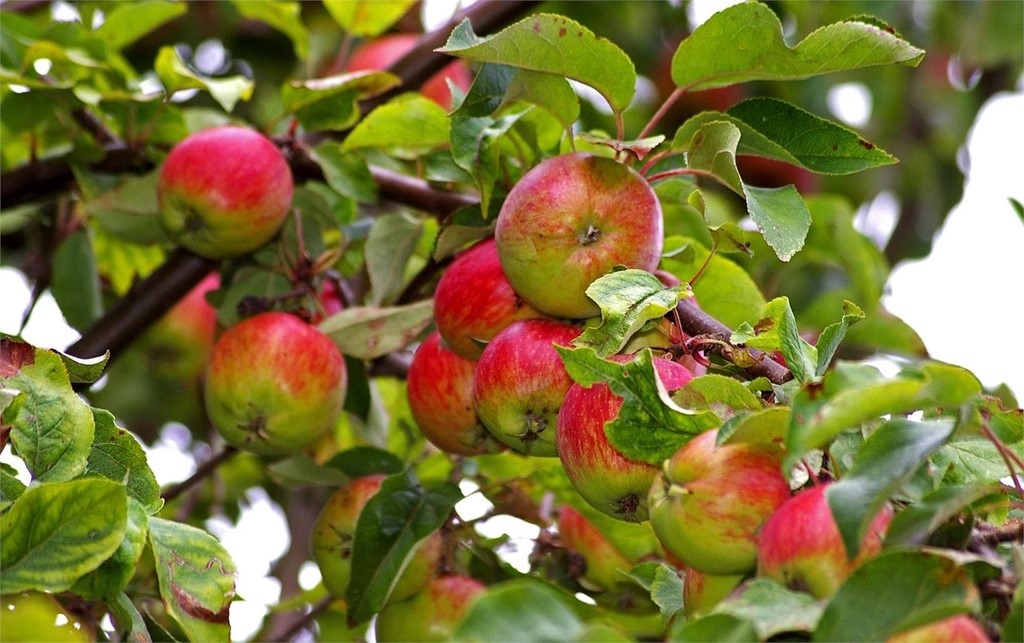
345,471,462,623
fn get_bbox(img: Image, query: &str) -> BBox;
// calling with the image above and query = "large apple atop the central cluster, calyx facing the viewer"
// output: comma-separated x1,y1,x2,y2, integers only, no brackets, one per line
495,153,664,319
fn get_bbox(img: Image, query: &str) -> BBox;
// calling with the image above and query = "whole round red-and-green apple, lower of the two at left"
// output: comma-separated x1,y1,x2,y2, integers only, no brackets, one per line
205,312,347,455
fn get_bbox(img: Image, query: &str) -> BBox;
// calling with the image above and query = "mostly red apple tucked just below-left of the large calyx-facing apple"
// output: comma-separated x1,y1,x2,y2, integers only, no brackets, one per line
434,239,543,359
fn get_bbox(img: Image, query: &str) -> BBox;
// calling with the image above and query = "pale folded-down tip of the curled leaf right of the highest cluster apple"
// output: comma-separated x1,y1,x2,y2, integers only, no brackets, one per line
743,183,811,261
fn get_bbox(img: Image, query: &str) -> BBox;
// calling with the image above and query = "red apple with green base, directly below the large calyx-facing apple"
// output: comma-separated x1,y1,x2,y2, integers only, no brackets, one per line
473,319,580,457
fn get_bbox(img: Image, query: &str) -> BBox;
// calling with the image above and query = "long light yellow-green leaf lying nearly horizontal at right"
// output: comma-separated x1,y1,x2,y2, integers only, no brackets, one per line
784,361,981,468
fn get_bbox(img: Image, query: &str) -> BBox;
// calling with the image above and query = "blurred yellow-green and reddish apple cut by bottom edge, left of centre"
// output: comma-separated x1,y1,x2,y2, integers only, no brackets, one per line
377,575,487,642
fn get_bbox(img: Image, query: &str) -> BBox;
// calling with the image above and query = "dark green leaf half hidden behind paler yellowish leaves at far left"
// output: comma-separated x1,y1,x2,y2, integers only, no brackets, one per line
85,409,164,514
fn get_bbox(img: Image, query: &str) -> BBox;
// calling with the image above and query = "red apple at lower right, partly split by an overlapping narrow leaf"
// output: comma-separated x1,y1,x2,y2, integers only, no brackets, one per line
758,483,893,598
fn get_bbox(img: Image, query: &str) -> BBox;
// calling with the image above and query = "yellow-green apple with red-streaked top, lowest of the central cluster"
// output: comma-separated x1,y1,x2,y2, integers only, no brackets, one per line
648,429,790,574
